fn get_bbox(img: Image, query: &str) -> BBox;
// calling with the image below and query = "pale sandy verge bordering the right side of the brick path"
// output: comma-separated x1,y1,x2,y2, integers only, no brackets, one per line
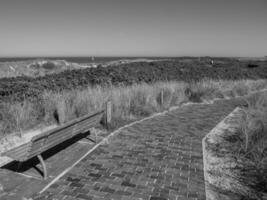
202,107,266,200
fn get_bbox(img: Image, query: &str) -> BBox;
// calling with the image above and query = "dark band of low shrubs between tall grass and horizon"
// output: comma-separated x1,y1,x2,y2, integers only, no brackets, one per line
0,60,267,102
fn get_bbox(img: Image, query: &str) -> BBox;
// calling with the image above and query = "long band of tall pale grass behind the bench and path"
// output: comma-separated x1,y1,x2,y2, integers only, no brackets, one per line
0,80,267,137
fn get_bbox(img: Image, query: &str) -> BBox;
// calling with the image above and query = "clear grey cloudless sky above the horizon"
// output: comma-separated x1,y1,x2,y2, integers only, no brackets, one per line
0,0,267,57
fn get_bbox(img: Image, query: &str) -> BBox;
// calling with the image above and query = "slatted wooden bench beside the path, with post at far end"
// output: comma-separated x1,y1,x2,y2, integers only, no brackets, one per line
2,101,111,179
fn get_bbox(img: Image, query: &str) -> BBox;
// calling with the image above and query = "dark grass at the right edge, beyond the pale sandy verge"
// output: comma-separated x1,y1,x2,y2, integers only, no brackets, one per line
237,92,267,193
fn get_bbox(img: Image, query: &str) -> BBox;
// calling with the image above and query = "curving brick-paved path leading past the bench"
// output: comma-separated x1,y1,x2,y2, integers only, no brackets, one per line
33,100,246,200
